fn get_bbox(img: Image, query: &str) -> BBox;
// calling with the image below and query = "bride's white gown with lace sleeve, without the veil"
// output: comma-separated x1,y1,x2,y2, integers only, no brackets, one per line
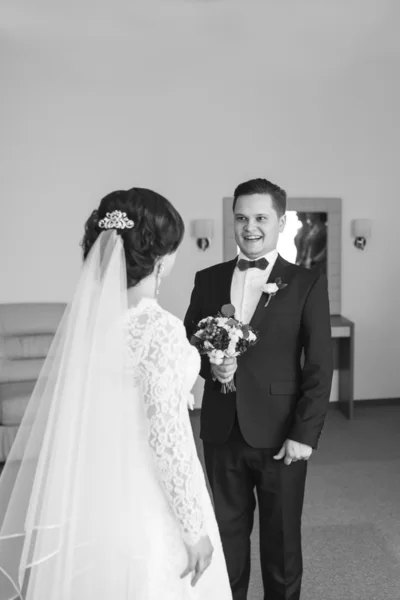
127,299,232,600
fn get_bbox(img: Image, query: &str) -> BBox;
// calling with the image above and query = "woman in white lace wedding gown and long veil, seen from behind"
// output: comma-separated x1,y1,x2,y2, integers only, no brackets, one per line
0,188,232,600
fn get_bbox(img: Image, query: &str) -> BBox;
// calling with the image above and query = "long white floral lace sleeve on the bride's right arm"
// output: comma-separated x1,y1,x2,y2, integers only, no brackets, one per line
130,311,204,544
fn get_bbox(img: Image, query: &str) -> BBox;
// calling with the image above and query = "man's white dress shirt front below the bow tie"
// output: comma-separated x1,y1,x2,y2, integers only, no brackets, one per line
231,250,278,323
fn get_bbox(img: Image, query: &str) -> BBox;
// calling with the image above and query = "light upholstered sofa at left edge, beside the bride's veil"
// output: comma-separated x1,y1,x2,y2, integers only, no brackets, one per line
0,303,66,463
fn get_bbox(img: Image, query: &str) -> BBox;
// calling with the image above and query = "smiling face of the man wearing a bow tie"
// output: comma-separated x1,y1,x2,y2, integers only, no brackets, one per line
234,194,286,260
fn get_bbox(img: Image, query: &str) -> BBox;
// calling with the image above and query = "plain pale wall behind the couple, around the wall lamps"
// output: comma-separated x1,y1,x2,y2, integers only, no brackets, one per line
0,0,400,406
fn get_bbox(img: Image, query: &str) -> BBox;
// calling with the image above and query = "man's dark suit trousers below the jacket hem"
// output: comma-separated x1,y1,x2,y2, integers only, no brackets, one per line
203,420,307,600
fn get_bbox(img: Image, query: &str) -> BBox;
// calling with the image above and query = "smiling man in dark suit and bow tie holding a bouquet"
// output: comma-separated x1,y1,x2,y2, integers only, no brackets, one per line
185,179,332,600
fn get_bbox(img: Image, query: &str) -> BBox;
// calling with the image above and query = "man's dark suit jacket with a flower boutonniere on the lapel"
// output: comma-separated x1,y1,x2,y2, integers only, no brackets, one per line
185,255,333,448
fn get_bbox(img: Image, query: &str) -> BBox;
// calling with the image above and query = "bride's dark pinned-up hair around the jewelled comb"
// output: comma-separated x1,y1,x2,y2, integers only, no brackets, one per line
81,188,185,287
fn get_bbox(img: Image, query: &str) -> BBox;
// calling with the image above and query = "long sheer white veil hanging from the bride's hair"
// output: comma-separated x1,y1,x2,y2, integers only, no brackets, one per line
0,230,159,600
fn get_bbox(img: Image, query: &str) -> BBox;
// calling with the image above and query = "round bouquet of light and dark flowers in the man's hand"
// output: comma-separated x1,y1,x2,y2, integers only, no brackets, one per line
190,304,257,394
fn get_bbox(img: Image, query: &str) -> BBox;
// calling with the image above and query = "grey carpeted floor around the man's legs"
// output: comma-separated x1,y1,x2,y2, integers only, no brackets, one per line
192,405,400,600
